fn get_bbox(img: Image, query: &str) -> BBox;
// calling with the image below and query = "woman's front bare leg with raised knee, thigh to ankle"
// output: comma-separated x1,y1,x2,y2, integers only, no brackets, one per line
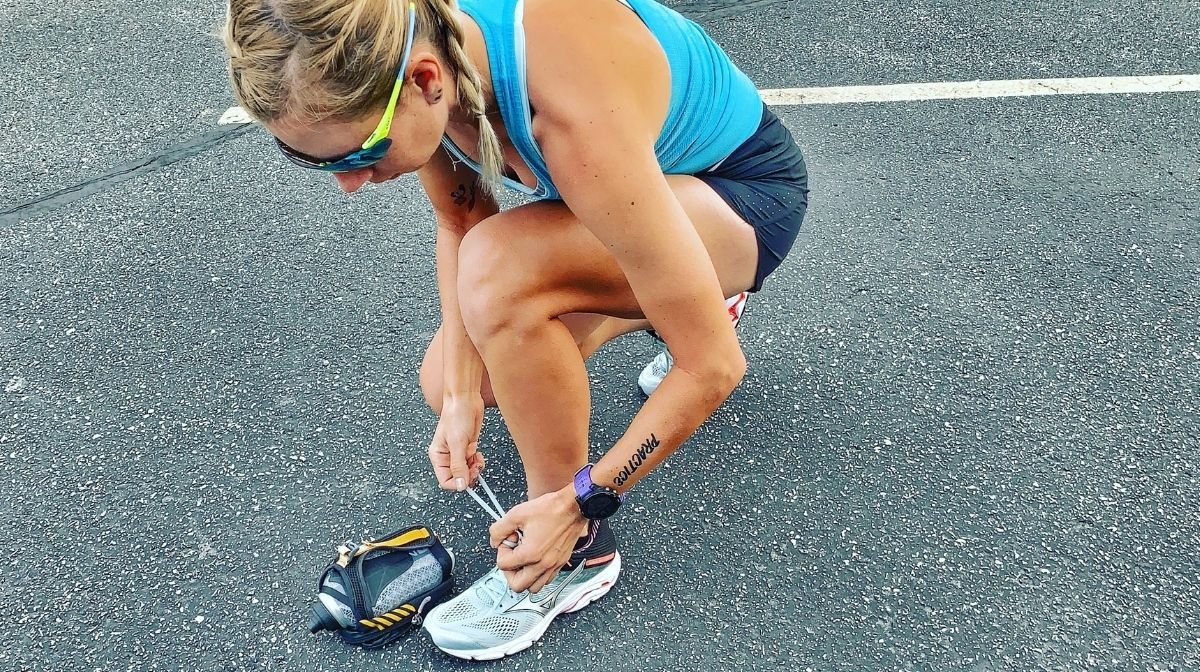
432,176,757,499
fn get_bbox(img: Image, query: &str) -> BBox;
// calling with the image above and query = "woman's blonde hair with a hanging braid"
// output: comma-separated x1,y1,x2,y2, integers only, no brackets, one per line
222,0,504,191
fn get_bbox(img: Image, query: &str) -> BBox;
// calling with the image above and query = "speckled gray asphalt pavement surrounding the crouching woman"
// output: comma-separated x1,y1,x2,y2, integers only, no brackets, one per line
0,0,1200,672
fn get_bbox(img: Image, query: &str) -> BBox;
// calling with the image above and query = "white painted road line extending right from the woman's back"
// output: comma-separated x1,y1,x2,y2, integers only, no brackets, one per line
760,74,1200,104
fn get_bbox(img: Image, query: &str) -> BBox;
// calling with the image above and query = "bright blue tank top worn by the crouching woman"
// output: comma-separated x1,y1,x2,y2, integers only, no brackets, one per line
442,0,762,199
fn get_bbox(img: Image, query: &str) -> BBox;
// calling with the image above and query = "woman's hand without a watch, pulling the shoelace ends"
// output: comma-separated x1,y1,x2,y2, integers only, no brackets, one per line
430,395,484,491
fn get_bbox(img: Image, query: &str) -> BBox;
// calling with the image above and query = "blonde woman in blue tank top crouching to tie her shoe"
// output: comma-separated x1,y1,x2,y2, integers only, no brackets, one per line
226,0,808,659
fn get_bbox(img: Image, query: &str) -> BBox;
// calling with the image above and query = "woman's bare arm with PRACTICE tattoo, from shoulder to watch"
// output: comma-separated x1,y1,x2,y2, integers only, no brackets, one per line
529,4,745,491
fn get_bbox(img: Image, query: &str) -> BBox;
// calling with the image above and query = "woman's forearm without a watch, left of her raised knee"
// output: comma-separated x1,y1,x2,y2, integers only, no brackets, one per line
437,226,484,400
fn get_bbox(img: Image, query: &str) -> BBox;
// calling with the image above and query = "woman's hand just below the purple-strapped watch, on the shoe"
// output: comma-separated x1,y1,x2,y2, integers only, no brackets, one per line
491,486,588,593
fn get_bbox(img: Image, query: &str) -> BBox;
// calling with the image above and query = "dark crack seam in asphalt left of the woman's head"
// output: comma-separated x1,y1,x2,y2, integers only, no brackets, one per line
0,124,253,227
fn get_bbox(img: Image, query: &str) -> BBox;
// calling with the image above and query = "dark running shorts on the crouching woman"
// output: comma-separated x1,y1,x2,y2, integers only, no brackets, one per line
696,104,809,292
